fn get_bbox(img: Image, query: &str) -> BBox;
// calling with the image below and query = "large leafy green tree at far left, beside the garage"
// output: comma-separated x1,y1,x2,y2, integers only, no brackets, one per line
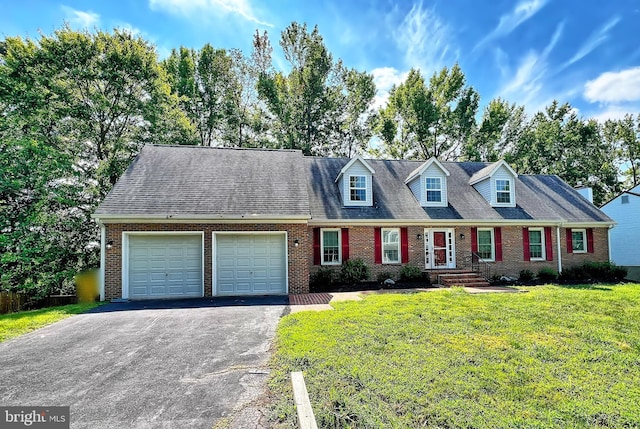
0,27,189,291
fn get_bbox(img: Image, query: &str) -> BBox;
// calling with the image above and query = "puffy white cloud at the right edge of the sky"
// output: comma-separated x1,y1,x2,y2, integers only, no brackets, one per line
584,67,640,103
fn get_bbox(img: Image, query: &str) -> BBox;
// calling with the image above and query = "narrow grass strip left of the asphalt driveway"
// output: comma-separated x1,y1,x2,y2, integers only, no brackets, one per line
0,303,100,342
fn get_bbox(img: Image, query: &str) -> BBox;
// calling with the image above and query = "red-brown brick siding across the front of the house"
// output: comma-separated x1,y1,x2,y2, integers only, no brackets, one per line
105,223,609,300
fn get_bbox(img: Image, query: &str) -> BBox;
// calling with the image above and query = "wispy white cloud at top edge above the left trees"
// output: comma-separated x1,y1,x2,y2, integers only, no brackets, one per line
149,0,273,27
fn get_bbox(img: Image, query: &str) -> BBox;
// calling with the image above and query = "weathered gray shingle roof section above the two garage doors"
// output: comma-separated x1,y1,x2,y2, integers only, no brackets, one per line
95,145,309,218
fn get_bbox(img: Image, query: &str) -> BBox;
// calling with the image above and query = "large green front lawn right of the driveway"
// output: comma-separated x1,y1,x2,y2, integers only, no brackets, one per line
270,285,640,428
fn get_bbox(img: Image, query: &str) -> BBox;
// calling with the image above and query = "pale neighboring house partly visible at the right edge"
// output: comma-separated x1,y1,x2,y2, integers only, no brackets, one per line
601,185,640,281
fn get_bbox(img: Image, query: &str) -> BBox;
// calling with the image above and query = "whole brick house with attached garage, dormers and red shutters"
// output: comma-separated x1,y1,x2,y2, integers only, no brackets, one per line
93,145,613,299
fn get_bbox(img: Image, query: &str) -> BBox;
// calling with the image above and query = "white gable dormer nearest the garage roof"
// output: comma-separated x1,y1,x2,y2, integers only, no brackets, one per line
336,155,375,207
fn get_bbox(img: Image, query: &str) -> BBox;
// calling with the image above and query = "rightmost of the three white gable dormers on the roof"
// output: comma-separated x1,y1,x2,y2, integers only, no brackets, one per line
469,160,518,207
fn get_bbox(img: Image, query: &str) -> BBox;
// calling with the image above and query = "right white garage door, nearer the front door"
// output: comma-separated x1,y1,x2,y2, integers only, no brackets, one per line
215,234,287,295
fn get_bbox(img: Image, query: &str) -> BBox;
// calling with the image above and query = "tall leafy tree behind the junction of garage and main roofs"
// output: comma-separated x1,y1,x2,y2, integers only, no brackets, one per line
253,22,375,156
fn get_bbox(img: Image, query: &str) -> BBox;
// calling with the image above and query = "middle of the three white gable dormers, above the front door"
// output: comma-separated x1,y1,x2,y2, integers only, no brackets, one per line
404,158,449,207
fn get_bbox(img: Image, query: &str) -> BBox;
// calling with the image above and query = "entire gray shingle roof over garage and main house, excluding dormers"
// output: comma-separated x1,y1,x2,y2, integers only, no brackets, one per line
95,145,612,222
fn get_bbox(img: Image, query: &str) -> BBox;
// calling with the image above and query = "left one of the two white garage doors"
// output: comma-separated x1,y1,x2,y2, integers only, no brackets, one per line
128,234,203,299
